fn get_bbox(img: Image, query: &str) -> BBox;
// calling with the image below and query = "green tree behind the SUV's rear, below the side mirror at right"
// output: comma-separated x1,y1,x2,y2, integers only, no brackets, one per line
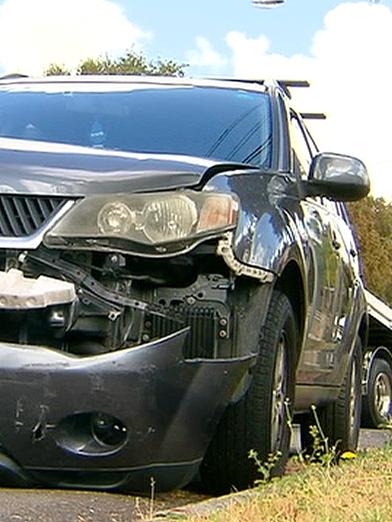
349,197,392,305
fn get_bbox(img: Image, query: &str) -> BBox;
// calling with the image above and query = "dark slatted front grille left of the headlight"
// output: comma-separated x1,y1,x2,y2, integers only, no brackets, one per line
0,195,67,237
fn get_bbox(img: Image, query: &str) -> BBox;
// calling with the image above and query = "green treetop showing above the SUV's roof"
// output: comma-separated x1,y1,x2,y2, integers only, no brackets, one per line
45,50,187,77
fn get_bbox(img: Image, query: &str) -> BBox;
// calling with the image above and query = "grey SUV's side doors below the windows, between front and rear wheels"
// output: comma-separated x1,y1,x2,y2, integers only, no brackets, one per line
297,199,365,394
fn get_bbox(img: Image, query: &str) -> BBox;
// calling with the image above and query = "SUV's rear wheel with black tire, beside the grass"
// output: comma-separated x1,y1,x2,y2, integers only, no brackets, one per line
319,336,362,454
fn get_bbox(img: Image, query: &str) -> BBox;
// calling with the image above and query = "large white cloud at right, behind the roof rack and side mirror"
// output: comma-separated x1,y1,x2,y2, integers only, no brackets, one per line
226,2,392,199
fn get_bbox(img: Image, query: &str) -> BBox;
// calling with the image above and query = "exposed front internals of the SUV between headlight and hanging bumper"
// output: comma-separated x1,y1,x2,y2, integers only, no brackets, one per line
0,241,234,358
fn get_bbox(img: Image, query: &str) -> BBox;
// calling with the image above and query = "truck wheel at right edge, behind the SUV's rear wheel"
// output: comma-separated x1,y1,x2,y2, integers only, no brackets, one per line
362,359,392,428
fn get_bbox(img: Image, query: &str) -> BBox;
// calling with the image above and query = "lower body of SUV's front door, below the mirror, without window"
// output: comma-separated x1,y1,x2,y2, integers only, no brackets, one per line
297,199,352,385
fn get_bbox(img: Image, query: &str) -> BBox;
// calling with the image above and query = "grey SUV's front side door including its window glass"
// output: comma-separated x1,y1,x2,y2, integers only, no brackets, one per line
290,113,349,386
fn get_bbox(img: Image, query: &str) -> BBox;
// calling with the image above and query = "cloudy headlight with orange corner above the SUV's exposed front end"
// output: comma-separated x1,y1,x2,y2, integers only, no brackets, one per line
45,190,239,255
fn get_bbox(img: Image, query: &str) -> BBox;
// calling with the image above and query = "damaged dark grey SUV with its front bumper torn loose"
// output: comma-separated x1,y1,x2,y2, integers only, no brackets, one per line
0,77,369,493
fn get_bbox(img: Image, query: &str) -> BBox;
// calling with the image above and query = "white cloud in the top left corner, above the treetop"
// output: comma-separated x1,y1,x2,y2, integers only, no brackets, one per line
0,0,149,74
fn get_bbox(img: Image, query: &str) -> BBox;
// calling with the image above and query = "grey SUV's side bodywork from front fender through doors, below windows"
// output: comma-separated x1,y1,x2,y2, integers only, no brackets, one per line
204,172,363,396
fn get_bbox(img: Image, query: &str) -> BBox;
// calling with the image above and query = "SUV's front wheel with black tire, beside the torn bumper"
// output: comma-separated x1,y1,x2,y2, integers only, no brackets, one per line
200,291,298,494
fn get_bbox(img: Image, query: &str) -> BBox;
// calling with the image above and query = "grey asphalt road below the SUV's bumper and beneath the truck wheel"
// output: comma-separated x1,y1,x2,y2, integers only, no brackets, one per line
0,430,392,522
